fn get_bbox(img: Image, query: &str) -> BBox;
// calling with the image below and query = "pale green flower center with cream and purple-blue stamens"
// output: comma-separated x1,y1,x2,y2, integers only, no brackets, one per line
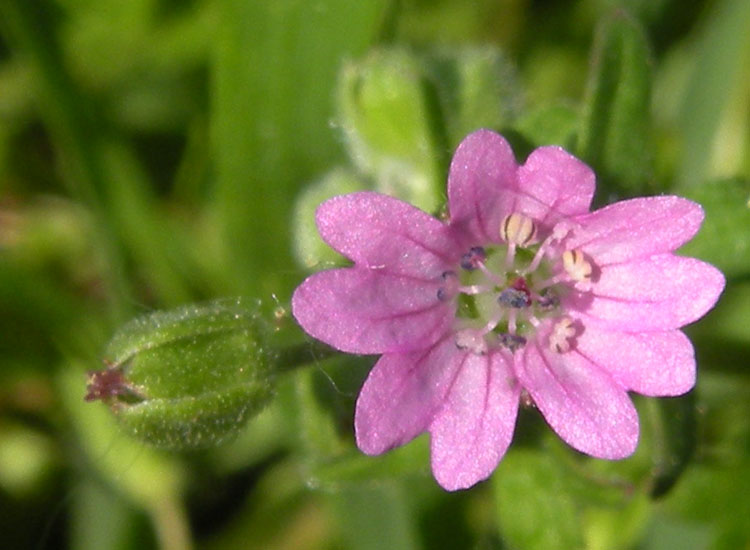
438,213,593,354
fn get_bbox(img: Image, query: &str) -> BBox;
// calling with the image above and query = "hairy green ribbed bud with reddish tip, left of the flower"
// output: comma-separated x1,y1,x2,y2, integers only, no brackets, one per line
86,300,273,450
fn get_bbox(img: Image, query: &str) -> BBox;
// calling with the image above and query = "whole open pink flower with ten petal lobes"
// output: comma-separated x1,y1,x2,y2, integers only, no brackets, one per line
292,130,724,490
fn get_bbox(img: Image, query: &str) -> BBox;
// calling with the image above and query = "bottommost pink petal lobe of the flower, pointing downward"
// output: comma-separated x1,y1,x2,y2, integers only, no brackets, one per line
429,352,520,491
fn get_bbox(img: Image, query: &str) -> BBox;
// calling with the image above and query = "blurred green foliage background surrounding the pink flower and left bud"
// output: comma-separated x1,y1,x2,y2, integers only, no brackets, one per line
0,0,750,550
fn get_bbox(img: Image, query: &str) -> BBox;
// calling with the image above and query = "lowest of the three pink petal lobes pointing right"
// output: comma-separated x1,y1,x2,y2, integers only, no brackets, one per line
575,326,695,396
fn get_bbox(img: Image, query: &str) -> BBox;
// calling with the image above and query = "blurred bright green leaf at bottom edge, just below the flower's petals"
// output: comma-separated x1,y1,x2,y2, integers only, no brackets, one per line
493,449,651,550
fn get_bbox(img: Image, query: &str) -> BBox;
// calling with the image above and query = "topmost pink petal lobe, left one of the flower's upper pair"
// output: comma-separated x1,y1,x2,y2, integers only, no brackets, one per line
448,130,517,244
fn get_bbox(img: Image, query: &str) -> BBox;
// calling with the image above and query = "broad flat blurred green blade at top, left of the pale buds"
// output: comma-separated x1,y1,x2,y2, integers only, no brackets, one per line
211,0,388,296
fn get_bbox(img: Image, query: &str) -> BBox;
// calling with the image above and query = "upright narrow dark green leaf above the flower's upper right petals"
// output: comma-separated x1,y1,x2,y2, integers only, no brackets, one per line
578,10,653,196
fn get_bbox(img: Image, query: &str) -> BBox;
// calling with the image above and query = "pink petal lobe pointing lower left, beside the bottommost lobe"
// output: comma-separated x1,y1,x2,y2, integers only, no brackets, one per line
354,338,467,455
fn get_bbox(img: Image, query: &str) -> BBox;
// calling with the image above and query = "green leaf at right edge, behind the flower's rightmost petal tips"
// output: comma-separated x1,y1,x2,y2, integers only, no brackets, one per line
679,178,750,279
